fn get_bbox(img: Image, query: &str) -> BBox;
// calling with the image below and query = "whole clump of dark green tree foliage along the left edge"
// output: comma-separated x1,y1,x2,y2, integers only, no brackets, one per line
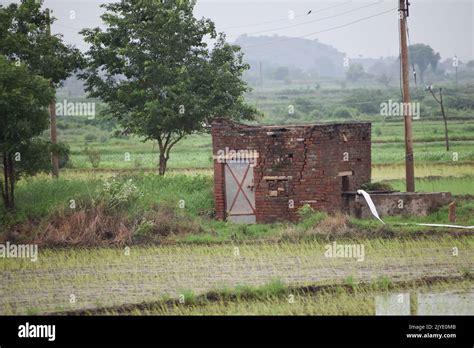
0,0,83,209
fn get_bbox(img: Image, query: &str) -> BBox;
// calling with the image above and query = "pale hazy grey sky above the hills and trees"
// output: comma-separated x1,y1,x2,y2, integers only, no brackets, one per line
0,0,474,61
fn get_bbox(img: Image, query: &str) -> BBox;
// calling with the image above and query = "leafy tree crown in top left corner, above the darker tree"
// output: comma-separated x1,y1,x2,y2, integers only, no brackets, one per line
0,0,84,177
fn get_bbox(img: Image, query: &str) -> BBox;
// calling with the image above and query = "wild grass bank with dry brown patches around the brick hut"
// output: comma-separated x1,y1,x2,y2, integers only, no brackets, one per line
0,173,474,246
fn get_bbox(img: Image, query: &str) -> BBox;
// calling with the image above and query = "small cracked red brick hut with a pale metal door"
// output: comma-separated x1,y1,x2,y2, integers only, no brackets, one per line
212,119,371,223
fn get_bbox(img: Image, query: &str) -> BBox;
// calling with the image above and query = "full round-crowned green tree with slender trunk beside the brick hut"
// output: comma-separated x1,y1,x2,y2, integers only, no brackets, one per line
81,0,256,175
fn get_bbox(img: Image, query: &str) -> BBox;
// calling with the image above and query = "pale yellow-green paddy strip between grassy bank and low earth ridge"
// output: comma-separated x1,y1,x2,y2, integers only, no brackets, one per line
0,236,474,314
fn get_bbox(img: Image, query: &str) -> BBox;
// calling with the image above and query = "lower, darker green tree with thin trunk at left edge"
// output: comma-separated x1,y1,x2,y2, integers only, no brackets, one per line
0,56,53,209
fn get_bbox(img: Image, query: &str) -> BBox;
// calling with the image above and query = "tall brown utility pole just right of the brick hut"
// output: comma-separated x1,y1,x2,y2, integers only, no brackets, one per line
398,0,415,192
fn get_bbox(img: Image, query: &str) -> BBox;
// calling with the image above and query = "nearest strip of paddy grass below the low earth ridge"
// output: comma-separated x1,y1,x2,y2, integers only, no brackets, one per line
112,279,474,315
